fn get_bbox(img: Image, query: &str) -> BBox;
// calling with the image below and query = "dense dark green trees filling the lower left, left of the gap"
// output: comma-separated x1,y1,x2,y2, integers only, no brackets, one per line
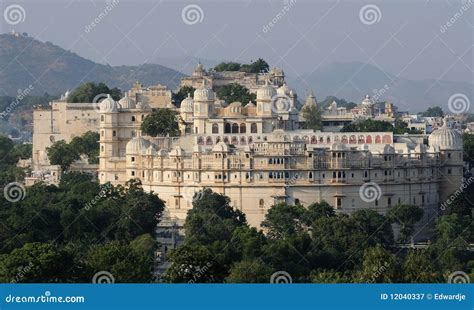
0,173,164,282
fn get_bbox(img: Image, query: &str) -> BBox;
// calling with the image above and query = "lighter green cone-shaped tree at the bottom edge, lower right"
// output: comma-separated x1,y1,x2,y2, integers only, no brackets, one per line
358,245,400,283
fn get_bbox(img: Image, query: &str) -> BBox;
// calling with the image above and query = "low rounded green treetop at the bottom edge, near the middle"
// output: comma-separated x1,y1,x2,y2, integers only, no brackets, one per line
225,259,273,283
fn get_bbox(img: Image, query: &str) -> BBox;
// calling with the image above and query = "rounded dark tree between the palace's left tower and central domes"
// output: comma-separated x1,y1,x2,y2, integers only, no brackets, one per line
140,108,179,137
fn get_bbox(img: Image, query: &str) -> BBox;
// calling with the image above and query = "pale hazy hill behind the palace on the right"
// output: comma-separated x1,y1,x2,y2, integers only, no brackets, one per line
287,62,474,112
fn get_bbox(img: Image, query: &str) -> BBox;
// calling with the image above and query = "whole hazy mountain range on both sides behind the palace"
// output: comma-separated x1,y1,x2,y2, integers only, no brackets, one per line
0,34,474,112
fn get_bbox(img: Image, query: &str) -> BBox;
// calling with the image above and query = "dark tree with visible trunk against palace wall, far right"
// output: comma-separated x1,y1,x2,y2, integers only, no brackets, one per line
387,204,423,242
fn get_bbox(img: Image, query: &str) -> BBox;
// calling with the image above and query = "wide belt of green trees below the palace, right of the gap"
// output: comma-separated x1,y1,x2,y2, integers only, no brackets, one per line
164,186,474,283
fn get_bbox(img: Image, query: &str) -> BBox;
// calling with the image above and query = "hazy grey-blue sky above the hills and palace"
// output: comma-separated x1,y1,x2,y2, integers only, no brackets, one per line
0,0,474,82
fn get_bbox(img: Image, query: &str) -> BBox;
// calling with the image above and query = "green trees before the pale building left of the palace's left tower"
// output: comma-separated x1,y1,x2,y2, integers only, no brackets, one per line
46,131,99,171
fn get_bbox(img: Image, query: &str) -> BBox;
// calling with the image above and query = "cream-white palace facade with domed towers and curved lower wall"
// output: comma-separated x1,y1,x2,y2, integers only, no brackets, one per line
98,84,463,237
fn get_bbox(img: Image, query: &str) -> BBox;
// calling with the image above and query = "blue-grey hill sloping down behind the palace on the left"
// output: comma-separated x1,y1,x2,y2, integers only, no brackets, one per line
0,34,184,96
